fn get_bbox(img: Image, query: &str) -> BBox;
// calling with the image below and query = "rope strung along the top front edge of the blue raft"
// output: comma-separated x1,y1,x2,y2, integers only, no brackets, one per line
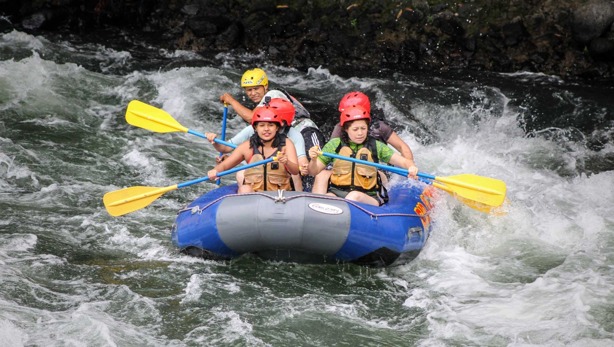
177,190,431,219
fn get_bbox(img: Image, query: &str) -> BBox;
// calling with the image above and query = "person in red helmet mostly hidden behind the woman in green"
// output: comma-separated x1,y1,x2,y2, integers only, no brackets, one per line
312,91,417,194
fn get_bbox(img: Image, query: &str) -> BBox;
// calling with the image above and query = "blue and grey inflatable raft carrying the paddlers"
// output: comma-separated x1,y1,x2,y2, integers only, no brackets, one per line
172,181,433,267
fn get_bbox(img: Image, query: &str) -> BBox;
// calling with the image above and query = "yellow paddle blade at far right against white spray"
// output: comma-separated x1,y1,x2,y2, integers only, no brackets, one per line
435,174,507,207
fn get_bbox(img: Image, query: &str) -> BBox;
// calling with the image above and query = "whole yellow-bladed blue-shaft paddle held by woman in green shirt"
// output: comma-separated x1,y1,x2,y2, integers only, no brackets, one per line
321,152,506,212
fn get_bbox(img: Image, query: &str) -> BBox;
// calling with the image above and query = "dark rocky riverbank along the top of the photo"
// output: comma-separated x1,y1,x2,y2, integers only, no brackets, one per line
0,0,614,80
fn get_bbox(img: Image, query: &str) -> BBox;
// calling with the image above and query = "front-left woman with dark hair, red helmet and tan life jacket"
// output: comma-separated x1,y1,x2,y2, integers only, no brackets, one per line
207,102,299,194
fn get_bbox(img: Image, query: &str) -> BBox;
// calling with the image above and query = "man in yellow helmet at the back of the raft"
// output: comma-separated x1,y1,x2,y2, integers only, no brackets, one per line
215,68,324,190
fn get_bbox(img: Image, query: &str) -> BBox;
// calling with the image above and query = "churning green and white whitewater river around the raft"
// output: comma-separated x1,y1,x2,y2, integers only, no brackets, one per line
0,32,614,347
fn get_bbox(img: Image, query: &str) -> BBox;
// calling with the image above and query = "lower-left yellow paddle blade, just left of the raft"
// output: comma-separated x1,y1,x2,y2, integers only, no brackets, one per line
102,184,177,217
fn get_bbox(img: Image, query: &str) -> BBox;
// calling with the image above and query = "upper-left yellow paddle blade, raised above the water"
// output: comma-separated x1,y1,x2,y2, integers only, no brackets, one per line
126,100,188,133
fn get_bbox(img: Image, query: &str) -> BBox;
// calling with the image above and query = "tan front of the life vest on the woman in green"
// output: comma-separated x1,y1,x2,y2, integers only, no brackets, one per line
330,146,379,192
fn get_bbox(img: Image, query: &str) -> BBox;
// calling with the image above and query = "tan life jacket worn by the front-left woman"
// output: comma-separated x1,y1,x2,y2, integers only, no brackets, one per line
243,145,294,192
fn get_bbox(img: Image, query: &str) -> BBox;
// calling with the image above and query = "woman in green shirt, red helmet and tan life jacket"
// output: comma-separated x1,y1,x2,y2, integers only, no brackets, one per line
309,105,418,206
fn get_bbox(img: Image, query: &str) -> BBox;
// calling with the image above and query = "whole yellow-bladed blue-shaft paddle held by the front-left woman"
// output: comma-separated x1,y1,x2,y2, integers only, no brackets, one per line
103,157,277,217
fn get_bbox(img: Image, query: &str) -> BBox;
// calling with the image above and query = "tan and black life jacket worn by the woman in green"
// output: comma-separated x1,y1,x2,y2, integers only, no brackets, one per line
330,137,388,202
